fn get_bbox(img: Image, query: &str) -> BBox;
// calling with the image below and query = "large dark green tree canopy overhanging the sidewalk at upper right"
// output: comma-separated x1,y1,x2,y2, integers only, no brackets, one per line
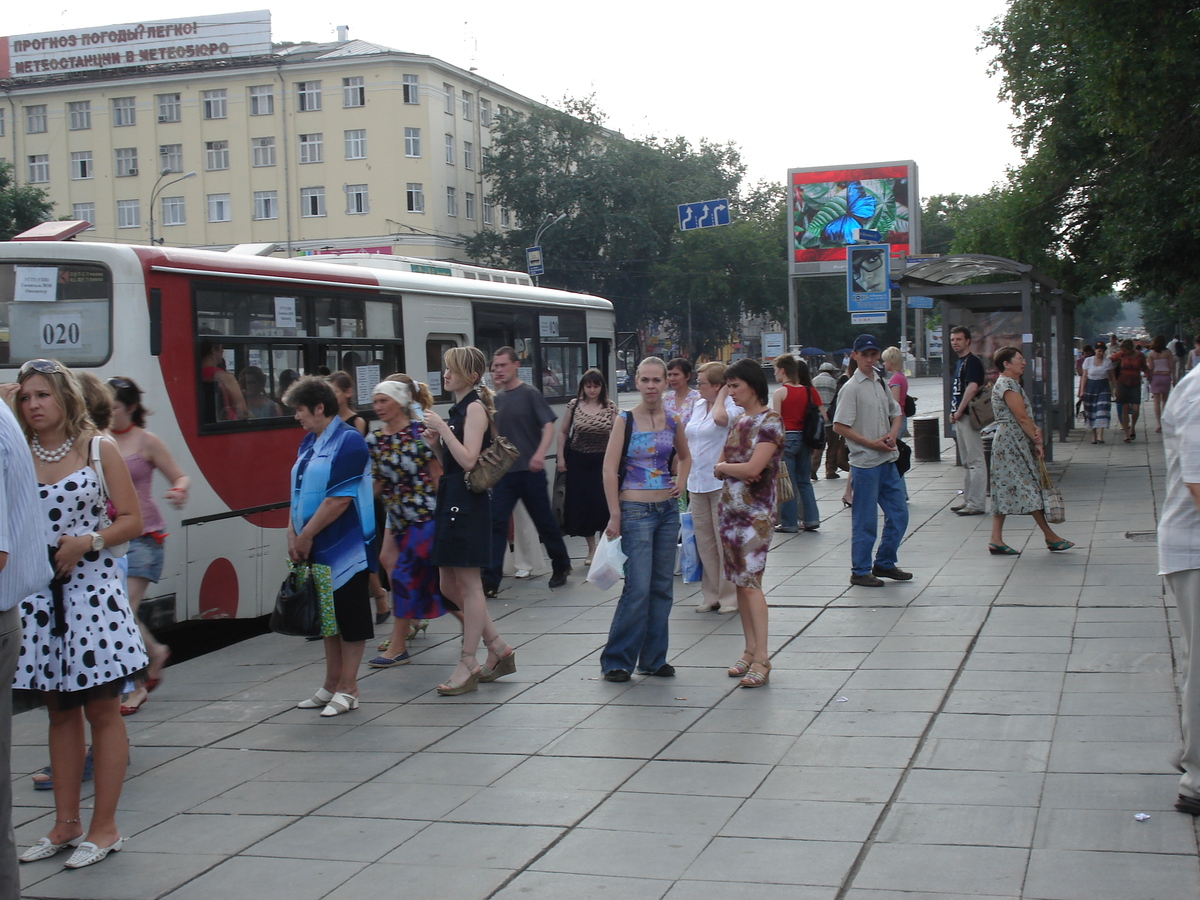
979,0,1200,312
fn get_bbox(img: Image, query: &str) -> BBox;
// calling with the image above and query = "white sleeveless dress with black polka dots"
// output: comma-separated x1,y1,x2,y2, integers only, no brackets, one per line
13,466,150,706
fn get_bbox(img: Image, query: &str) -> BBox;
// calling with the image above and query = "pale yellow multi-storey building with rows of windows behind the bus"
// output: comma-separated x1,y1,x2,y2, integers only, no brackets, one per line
0,31,533,259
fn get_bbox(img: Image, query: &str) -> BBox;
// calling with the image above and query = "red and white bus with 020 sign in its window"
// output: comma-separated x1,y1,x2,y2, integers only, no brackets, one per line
0,237,616,624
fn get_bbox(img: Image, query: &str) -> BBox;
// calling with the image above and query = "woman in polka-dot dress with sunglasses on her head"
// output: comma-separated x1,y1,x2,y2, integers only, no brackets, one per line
13,360,150,869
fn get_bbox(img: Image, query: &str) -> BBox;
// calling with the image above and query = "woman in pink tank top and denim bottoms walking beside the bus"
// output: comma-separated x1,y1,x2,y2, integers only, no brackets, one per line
108,377,191,715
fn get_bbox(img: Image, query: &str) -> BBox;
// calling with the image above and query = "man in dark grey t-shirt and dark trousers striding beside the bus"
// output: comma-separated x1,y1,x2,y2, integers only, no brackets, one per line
482,347,571,598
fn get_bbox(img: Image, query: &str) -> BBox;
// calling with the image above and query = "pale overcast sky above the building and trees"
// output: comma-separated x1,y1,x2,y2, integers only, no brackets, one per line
7,0,1020,199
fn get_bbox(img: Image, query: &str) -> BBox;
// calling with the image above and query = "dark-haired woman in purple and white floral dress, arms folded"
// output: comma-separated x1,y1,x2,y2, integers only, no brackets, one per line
713,359,784,688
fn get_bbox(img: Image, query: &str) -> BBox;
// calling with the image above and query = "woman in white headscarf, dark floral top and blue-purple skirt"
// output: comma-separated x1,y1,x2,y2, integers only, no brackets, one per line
367,380,446,668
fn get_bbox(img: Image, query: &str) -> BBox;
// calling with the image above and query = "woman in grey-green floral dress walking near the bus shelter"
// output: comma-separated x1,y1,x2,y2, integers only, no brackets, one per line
988,347,1075,556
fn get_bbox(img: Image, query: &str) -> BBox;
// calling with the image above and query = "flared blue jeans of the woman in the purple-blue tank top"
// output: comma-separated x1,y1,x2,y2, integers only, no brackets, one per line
600,499,679,672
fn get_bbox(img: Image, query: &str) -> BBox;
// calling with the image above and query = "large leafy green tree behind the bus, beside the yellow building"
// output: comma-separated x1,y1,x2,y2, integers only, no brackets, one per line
467,98,744,329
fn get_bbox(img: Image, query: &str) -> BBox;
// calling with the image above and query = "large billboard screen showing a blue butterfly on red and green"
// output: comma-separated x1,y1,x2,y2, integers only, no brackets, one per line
787,160,920,275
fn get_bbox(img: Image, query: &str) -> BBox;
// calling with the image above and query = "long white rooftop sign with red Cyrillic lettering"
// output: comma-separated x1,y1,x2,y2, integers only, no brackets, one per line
0,10,271,78
